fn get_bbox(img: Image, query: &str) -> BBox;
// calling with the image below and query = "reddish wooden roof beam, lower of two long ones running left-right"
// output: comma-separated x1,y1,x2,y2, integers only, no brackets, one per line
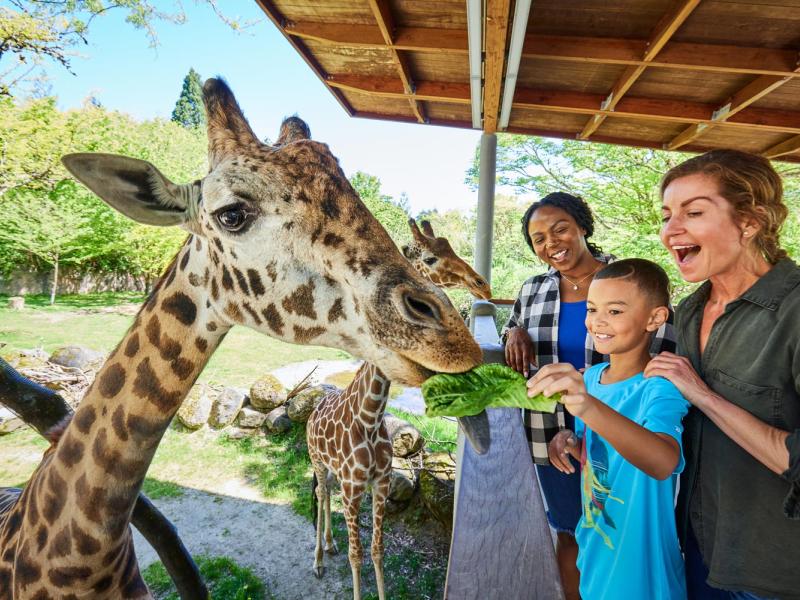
327,74,800,133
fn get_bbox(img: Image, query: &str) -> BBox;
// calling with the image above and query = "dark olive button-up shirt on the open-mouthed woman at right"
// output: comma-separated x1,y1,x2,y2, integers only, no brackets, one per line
675,259,800,600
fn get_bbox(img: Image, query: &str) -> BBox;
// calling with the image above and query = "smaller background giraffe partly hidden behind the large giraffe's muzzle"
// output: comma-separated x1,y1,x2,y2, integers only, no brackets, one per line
306,219,491,600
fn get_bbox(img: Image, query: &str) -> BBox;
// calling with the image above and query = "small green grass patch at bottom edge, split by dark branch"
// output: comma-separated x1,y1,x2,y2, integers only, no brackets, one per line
142,556,272,600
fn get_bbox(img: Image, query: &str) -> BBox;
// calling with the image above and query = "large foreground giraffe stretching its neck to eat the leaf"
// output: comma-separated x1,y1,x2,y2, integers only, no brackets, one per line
0,79,481,600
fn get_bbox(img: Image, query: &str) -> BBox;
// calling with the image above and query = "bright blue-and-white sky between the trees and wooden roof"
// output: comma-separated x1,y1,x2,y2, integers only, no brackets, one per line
36,0,488,215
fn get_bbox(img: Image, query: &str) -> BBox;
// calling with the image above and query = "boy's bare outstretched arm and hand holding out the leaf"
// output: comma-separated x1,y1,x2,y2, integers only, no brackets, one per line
528,363,681,479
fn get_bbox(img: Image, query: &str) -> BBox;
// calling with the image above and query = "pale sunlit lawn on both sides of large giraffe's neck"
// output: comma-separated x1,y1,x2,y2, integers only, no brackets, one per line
0,293,351,386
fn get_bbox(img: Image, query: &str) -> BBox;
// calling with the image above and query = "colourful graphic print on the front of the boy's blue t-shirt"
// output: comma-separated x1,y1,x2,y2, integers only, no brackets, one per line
581,432,625,550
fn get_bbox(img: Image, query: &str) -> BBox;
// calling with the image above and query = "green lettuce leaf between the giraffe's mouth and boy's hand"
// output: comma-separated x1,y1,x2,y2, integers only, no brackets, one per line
422,364,561,417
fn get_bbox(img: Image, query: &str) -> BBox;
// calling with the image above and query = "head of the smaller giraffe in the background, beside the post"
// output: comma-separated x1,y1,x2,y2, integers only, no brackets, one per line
403,219,492,300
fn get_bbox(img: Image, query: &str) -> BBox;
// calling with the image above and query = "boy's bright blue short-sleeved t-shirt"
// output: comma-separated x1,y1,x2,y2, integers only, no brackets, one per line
575,363,689,600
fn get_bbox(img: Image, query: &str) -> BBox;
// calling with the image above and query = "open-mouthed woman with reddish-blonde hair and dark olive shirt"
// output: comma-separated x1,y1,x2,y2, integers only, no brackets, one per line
645,150,800,600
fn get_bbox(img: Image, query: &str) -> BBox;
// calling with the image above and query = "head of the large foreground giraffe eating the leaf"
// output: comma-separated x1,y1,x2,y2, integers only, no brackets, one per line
63,79,482,385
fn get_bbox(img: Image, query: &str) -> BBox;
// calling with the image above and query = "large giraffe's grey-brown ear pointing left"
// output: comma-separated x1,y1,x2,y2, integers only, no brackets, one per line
61,153,200,226
